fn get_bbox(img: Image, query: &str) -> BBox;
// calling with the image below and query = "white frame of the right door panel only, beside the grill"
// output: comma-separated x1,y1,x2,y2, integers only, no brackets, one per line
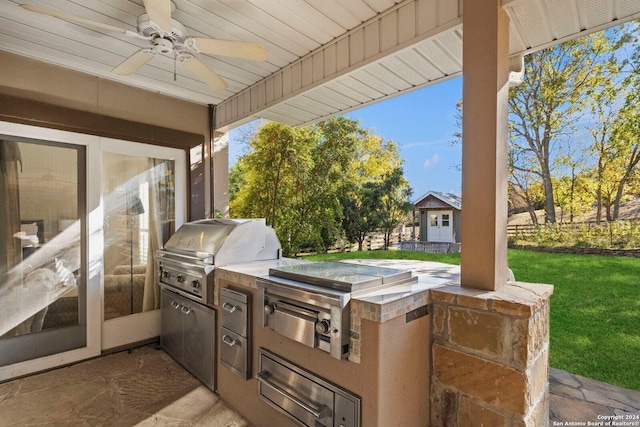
99,138,187,350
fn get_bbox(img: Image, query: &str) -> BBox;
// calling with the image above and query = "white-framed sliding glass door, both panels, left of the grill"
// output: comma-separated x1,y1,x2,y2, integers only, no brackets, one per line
0,121,187,381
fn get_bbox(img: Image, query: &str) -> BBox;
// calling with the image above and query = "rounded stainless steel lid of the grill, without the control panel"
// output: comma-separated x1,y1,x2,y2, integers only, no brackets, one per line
163,218,280,265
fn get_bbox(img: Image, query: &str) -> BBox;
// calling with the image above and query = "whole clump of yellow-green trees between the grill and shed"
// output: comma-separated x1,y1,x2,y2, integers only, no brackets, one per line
230,117,410,255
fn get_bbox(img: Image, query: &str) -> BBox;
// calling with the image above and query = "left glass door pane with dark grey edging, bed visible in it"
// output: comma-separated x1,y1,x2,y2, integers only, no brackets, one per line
0,137,87,366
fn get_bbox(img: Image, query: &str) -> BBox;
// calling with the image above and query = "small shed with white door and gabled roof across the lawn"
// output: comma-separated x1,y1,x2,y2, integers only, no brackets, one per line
414,191,462,243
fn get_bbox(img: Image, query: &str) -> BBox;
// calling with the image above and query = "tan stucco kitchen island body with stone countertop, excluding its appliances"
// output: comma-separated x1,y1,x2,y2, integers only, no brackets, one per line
214,259,457,427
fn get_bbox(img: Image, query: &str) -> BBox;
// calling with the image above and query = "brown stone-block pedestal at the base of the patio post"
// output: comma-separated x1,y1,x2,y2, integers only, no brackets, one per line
430,282,553,427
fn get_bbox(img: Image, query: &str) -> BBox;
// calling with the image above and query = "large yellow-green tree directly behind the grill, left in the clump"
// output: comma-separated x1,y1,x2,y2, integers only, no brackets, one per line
230,118,359,255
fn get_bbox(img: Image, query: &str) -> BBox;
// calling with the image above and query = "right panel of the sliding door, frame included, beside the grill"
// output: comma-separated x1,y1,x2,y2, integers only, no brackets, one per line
102,141,186,348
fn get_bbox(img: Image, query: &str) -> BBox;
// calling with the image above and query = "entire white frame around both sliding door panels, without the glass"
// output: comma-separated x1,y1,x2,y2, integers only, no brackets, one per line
0,120,188,381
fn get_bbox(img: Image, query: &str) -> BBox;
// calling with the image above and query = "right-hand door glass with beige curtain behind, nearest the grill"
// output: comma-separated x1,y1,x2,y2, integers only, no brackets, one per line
102,152,176,321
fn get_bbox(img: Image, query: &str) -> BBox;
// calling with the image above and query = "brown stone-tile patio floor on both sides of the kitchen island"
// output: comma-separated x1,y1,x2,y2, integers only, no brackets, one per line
0,345,640,427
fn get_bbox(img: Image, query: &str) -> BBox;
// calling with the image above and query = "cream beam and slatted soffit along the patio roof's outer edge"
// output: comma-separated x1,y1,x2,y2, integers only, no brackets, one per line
216,0,640,131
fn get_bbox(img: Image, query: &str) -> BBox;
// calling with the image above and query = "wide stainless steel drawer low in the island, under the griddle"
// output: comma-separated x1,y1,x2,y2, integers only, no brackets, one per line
256,349,360,427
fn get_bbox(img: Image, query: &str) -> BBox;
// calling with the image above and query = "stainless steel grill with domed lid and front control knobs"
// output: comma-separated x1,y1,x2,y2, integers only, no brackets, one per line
155,219,281,305
